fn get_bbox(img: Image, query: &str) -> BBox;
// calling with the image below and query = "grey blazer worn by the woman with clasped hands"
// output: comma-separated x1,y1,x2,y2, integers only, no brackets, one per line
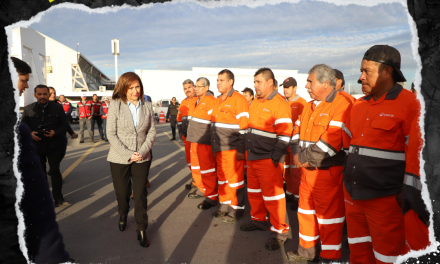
106,99,156,164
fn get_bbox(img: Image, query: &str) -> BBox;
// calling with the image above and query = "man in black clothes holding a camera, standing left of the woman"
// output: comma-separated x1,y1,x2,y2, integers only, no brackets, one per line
22,84,67,207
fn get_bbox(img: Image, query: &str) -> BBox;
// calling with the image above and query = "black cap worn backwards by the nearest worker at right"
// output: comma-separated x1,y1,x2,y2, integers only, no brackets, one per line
362,45,406,82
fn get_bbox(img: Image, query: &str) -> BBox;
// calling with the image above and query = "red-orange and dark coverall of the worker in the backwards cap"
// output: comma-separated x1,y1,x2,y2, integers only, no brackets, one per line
343,83,420,263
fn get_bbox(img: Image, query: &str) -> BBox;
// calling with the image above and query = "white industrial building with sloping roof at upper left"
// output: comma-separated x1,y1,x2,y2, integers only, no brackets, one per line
10,27,114,107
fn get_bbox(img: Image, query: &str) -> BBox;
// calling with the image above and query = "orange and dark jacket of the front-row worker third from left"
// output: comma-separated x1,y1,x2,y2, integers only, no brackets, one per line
211,89,249,154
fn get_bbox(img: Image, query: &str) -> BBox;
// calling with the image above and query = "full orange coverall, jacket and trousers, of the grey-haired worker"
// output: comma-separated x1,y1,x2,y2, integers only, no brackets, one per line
292,90,351,260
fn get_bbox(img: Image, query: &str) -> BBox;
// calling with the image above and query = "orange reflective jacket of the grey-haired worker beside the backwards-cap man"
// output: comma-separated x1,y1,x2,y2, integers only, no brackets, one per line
291,90,352,167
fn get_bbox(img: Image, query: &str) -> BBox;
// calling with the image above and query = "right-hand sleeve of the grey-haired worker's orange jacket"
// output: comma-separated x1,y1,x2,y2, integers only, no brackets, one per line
298,100,352,166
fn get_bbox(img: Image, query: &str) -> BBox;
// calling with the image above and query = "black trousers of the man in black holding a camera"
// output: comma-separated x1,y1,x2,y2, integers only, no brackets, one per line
37,146,66,201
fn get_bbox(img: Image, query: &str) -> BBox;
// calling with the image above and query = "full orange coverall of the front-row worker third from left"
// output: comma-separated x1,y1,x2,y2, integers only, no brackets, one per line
211,89,249,217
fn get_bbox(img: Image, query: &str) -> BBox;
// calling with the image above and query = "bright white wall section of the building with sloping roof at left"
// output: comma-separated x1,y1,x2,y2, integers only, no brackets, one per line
40,33,77,94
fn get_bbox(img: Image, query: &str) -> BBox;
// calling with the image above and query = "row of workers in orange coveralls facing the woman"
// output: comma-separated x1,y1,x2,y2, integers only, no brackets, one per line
177,45,430,263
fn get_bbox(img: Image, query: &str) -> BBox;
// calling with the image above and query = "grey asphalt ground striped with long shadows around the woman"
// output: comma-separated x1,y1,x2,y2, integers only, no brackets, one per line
52,124,349,264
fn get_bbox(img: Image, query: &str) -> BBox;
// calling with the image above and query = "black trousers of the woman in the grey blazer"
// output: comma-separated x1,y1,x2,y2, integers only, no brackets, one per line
110,162,150,230
